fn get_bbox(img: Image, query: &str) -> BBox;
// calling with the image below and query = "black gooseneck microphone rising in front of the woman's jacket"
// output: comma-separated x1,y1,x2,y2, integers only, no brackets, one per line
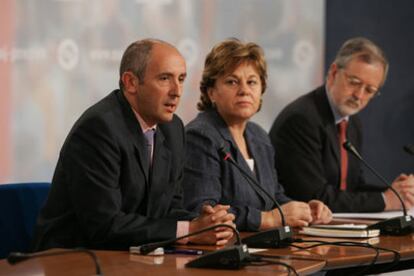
220,145,293,248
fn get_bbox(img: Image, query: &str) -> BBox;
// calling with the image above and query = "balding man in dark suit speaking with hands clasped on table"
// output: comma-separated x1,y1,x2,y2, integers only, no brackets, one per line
34,39,234,250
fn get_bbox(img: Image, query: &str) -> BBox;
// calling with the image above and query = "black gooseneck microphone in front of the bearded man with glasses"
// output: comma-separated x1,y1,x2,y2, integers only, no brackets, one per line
342,141,414,235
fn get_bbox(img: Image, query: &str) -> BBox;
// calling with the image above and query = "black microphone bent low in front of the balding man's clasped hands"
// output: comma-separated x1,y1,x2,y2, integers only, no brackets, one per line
139,224,251,269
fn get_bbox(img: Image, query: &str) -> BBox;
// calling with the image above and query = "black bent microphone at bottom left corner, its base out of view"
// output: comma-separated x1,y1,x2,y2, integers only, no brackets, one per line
7,248,103,275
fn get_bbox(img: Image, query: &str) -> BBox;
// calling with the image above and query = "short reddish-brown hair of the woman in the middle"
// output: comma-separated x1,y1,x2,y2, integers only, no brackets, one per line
197,38,267,111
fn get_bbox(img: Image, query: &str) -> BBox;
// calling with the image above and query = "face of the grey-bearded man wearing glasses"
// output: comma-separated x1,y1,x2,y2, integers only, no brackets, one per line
327,59,384,116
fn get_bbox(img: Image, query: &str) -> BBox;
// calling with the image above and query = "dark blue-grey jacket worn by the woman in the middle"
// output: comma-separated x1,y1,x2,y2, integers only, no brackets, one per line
183,110,290,231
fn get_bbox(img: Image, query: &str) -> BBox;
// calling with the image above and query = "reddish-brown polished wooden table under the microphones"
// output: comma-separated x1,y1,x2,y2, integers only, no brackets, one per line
0,231,414,276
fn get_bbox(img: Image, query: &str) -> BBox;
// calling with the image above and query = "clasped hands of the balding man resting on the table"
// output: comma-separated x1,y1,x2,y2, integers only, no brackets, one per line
189,204,236,245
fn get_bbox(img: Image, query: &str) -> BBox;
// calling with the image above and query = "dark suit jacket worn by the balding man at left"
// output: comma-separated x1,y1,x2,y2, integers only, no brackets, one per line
34,90,189,250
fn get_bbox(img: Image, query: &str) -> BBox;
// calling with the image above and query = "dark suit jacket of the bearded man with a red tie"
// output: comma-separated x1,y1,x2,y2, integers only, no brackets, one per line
270,86,385,212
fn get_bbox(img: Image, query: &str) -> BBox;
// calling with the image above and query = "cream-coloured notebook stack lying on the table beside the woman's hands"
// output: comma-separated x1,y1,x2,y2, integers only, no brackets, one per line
299,224,380,238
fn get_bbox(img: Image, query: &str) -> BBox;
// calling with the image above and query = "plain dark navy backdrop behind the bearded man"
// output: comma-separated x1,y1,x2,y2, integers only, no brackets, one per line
325,0,414,183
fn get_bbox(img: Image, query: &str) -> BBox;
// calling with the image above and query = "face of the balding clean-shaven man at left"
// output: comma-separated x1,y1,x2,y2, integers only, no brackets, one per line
135,43,187,126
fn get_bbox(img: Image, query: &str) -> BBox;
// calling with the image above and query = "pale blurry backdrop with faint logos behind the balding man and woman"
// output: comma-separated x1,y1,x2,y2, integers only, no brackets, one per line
0,0,324,183
